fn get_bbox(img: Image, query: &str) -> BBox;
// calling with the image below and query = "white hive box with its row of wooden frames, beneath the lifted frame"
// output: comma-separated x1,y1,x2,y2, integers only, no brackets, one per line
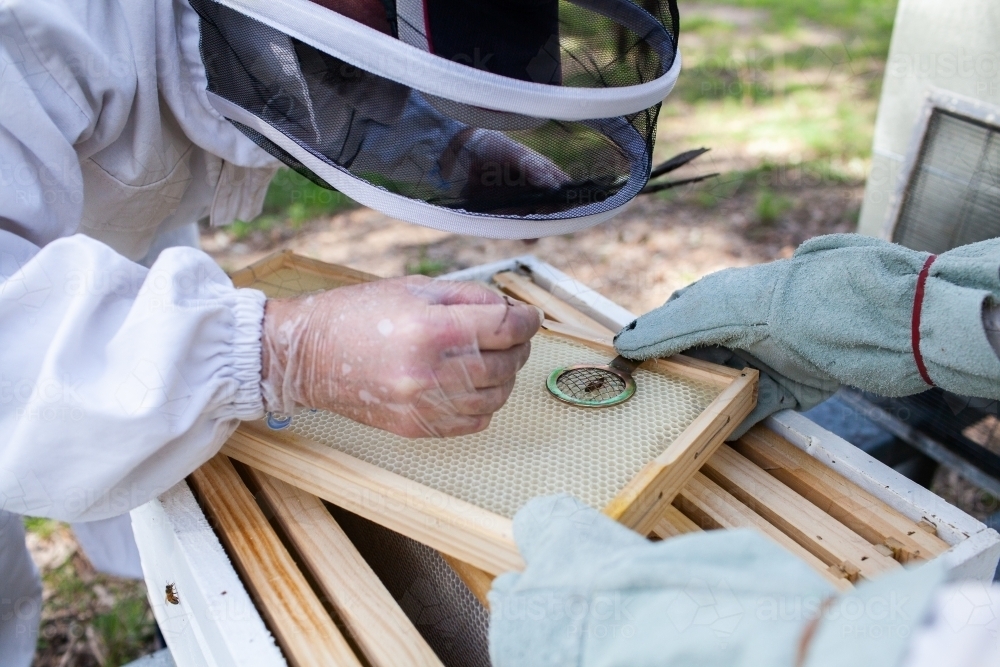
154,256,1000,667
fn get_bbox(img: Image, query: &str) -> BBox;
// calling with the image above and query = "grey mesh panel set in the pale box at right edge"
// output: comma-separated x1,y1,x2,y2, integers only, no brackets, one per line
892,109,1000,253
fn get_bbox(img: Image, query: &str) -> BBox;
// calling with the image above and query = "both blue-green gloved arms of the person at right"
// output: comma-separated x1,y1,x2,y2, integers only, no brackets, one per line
490,234,1000,667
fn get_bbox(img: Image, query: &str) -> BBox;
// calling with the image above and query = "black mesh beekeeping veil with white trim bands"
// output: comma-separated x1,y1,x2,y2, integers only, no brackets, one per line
191,0,680,238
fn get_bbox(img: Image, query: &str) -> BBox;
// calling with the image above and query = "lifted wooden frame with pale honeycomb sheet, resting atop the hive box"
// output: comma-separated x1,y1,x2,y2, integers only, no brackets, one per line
224,254,757,575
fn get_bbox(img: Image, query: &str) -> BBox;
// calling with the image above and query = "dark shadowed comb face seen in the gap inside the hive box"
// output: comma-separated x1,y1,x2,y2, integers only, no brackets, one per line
328,505,490,667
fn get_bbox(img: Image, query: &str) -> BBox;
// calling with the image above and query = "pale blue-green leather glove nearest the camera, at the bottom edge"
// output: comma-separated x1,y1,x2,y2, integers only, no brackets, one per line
489,496,945,667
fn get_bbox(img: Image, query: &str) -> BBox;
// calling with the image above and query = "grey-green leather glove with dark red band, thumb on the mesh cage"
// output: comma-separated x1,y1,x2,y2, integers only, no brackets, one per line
615,234,1000,439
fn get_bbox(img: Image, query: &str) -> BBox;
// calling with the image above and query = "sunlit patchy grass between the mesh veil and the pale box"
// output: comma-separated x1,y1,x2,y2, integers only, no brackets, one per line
654,0,896,201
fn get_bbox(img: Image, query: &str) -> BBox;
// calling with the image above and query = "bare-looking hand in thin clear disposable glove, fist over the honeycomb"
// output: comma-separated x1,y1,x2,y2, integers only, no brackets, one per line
261,276,541,437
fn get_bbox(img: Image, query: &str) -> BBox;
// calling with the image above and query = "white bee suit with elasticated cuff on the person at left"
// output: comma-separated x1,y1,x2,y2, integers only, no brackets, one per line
0,0,277,667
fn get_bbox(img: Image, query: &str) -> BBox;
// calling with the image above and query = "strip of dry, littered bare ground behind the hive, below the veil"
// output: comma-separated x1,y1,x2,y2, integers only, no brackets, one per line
202,179,863,313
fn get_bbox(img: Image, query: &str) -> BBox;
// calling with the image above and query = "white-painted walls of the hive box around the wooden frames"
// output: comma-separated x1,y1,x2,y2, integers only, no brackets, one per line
132,255,1000,667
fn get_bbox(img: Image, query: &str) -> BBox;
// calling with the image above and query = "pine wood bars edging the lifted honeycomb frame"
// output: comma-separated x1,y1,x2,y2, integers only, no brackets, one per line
223,252,757,574
